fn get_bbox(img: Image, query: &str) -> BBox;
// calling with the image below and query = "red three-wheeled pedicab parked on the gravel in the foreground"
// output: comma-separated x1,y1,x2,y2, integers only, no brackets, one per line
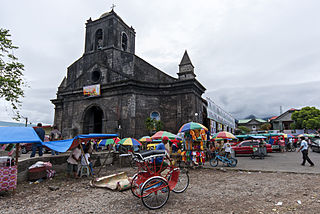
131,150,189,210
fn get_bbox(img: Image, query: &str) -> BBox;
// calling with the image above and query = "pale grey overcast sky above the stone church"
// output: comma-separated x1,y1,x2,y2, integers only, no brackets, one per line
0,0,320,124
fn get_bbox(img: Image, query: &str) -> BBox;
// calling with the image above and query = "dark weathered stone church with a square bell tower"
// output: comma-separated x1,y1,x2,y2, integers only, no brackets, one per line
51,10,206,138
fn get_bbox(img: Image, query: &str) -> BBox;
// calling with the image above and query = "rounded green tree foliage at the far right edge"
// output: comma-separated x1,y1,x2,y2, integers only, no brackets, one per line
291,106,320,129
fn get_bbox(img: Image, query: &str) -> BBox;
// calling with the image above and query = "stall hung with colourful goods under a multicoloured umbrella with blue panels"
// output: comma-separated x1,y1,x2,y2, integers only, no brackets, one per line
179,122,208,166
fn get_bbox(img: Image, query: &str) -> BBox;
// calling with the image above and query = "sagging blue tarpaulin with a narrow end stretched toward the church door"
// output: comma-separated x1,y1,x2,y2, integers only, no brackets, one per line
42,134,118,152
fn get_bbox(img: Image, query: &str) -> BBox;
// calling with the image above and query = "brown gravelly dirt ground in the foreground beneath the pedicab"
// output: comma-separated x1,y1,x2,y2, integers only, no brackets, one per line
0,168,320,214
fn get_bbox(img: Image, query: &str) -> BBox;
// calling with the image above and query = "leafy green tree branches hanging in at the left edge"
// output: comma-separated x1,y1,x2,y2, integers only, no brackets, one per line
0,28,25,119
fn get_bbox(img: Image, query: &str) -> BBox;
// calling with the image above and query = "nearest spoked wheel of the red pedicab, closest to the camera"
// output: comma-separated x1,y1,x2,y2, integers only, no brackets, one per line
141,176,170,210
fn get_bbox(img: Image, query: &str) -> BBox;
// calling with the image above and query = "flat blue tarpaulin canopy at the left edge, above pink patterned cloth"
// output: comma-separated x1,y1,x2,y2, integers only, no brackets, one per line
0,127,41,144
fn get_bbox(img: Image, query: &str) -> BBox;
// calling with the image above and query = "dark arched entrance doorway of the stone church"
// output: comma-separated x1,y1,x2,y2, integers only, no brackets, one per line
83,106,103,134
